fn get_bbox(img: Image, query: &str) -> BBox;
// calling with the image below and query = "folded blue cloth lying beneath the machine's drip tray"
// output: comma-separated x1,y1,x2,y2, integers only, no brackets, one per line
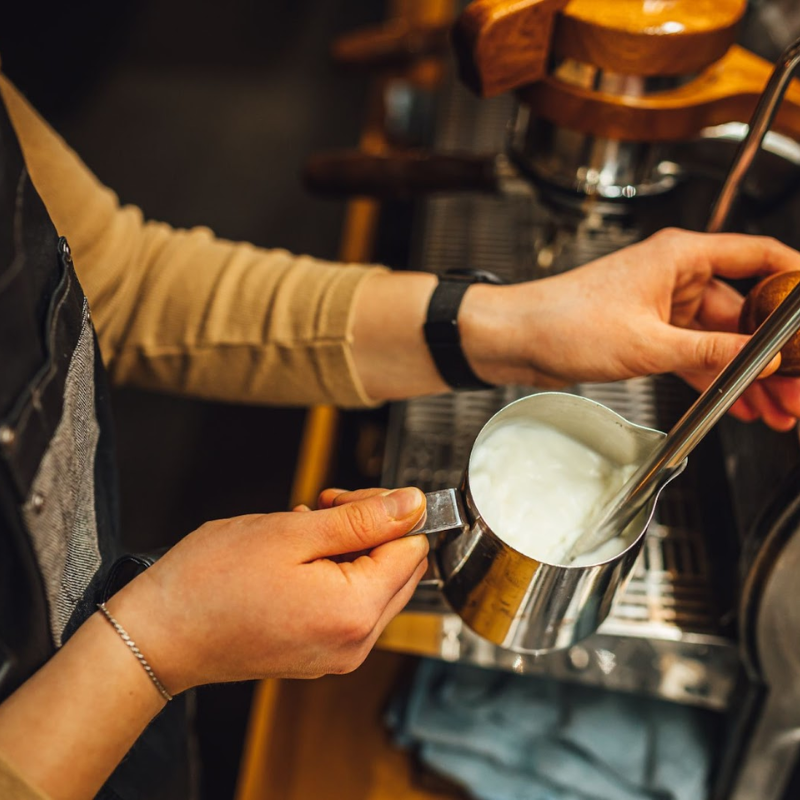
389,660,718,800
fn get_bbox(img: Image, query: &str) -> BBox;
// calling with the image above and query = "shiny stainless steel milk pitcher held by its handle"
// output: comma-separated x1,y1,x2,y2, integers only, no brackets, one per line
415,392,686,653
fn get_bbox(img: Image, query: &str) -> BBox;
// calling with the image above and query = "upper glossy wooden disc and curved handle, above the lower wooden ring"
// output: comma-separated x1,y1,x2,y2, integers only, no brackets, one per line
454,0,746,97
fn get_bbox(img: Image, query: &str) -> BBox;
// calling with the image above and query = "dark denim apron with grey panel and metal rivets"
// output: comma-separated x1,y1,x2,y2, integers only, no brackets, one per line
0,97,195,800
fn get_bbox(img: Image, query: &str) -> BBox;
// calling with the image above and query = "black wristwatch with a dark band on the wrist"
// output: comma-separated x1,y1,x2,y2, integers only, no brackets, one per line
424,269,503,389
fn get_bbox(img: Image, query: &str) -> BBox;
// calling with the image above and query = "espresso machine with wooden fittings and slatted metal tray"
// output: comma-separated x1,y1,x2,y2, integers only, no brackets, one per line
306,0,800,800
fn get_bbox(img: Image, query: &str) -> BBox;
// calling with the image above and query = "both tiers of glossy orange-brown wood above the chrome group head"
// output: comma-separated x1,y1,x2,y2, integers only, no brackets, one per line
453,0,800,141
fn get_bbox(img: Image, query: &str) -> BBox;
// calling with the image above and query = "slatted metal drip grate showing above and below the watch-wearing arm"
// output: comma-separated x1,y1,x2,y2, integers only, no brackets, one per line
383,72,738,708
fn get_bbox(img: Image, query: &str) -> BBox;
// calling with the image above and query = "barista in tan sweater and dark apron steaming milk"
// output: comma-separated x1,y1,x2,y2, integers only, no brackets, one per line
0,59,800,798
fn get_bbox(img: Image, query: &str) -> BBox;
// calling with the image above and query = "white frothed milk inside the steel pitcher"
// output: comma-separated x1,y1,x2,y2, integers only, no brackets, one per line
469,420,636,564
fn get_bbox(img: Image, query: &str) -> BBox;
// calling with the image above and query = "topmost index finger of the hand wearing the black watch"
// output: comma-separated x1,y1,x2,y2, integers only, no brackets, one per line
684,232,800,278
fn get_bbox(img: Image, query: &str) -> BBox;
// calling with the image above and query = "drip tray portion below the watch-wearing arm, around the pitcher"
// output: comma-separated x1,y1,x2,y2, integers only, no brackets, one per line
380,378,741,710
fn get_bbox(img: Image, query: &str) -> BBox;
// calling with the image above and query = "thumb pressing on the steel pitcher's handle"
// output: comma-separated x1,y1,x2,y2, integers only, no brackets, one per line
296,488,425,561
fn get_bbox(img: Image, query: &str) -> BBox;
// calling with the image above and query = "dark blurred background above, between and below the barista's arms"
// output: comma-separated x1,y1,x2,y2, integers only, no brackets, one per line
0,0,385,800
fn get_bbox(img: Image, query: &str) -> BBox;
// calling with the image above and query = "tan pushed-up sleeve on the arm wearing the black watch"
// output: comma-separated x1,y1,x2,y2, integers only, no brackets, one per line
0,76,380,407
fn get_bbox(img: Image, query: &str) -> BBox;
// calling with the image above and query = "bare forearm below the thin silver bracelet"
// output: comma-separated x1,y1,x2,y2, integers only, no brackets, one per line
0,614,165,800
